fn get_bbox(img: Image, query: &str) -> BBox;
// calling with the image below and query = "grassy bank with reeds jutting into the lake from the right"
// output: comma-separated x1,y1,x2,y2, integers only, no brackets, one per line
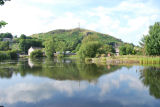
89,55,160,65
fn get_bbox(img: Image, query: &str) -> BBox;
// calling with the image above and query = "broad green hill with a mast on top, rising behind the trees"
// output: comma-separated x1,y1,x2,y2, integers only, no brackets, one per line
31,28,123,51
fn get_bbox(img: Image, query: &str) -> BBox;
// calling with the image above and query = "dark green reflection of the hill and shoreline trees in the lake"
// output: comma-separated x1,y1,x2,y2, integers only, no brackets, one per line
0,59,120,81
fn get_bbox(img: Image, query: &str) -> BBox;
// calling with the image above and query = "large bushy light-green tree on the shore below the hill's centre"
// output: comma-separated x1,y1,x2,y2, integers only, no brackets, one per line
78,35,114,58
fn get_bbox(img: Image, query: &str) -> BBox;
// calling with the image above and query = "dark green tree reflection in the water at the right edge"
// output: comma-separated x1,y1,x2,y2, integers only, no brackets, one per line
141,67,160,98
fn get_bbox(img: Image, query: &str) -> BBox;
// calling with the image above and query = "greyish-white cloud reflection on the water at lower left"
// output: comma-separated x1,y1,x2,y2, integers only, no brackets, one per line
0,80,86,104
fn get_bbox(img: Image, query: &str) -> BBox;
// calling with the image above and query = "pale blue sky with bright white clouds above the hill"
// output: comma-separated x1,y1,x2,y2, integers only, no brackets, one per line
0,0,160,45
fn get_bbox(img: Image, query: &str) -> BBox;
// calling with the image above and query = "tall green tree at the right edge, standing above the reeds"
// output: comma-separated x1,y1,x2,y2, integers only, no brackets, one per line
143,22,160,55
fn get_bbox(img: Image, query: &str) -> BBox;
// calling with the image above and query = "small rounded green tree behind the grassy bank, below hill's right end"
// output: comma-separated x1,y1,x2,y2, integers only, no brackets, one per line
119,44,136,55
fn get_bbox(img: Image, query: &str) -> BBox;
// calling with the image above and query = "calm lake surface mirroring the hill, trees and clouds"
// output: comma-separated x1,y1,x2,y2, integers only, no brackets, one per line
0,59,160,107
